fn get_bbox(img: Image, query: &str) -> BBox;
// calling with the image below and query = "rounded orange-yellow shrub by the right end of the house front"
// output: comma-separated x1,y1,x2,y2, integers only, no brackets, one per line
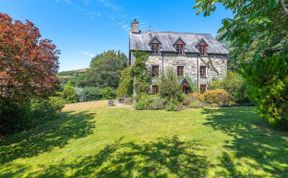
203,89,230,106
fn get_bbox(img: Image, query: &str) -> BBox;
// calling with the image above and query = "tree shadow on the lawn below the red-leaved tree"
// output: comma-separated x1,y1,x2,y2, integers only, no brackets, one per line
0,112,95,164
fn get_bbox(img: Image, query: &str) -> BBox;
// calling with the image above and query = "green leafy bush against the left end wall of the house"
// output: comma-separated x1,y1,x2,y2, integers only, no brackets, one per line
117,66,134,97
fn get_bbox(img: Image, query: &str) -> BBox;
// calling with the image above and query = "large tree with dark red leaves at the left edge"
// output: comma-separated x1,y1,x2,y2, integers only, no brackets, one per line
0,13,59,103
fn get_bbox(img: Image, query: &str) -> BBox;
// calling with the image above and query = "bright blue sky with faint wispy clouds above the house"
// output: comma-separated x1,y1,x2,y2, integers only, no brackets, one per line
0,0,232,71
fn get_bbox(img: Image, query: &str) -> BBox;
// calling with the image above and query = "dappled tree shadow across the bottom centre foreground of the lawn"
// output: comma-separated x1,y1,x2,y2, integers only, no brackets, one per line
35,137,209,178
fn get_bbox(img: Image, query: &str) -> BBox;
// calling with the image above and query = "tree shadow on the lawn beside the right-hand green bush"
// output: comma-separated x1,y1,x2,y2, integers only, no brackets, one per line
203,107,288,177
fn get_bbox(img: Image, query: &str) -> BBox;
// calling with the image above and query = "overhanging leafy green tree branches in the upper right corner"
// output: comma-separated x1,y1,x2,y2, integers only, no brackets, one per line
194,0,288,69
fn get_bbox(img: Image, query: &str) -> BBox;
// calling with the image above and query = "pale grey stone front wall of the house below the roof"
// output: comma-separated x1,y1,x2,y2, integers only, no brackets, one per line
146,54,227,88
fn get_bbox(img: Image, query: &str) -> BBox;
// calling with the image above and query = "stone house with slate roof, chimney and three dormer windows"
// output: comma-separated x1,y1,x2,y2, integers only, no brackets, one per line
129,19,228,93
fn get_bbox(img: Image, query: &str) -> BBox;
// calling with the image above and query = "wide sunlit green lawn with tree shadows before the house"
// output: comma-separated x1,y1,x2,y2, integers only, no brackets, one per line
0,102,288,178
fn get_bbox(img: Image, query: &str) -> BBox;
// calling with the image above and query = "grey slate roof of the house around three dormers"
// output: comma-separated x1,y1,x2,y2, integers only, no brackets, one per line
129,31,228,54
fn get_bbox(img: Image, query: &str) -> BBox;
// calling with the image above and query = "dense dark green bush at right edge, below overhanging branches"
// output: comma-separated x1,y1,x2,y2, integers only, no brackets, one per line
244,55,288,129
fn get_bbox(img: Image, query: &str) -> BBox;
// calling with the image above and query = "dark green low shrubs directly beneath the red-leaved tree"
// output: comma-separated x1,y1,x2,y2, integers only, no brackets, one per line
0,97,64,135
